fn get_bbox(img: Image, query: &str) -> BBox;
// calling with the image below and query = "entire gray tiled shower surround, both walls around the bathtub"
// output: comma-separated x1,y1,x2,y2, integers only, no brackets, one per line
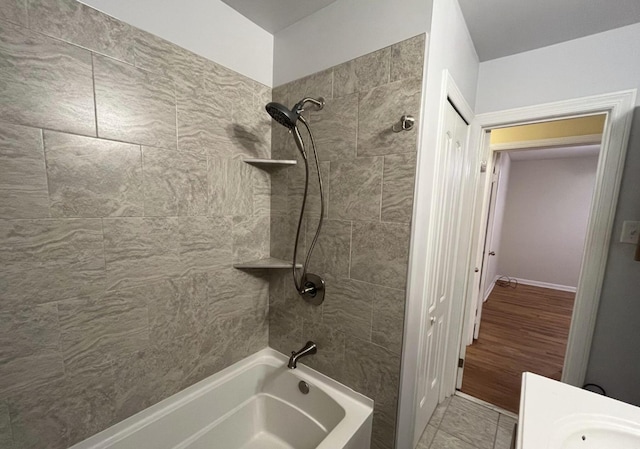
0,0,425,449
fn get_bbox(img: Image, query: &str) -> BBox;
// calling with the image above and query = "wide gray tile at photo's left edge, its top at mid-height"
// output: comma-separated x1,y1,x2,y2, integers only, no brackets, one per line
0,219,105,306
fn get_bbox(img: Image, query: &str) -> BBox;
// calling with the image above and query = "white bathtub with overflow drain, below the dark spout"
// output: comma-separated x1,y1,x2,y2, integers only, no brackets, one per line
71,348,373,449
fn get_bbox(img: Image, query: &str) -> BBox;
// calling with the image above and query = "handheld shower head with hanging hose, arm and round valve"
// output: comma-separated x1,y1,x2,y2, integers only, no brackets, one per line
265,97,324,306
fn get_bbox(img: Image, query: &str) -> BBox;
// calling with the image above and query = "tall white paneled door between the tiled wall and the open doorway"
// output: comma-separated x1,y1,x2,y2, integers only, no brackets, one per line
414,103,468,447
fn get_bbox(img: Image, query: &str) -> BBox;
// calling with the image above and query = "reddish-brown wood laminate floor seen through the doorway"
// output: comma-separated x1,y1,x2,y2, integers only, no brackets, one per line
462,284,575,413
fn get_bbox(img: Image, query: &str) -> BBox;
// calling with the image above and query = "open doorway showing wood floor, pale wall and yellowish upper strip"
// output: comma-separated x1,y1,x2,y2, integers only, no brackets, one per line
461,115,606,413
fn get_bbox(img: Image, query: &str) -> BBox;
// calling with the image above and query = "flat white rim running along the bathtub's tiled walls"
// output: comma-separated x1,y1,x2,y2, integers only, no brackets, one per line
69,347,374,449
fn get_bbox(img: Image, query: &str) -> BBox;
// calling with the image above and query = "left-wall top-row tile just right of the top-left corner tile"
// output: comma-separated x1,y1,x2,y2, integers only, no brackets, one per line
28,0,133,64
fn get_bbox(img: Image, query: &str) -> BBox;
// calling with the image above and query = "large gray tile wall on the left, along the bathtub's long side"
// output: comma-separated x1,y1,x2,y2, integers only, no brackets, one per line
0,0,271,449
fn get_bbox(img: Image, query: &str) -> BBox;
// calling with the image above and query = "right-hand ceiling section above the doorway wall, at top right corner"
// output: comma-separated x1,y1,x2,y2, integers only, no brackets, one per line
458,0,640,61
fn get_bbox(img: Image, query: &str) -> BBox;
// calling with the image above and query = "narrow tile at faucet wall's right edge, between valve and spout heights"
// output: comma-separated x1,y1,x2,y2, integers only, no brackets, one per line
371,286,405,355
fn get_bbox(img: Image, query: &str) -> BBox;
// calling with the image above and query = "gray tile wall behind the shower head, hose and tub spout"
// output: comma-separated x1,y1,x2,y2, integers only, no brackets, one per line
269,35,425,449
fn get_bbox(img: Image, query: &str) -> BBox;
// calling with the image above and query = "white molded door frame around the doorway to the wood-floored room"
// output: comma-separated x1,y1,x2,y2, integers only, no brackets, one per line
458,89,636,387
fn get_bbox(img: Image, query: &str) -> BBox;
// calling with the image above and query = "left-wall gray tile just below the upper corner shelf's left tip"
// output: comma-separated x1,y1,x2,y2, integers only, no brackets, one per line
208,155,253,215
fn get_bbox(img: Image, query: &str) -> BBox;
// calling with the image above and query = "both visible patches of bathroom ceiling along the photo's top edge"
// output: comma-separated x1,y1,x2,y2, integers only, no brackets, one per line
222,0,640,61
